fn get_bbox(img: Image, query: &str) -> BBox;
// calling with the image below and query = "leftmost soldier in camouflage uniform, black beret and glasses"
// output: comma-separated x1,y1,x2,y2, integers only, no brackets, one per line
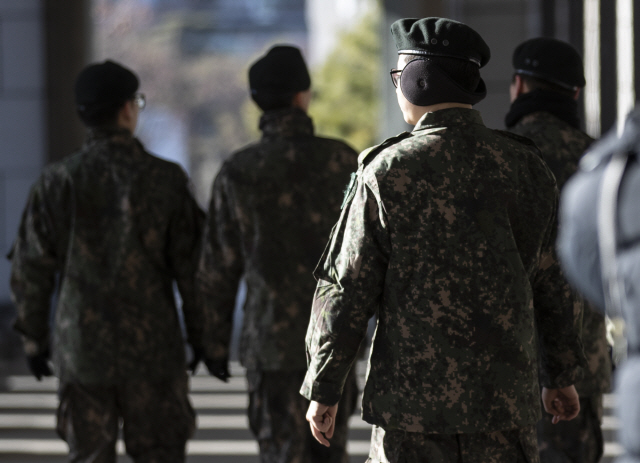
10,61,204,463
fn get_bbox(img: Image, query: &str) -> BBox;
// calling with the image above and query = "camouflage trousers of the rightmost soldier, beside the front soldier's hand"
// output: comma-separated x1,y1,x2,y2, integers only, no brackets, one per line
538,395,604,463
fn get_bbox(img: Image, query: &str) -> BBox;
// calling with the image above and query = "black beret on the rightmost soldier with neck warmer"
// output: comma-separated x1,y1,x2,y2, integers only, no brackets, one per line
513,37,586,89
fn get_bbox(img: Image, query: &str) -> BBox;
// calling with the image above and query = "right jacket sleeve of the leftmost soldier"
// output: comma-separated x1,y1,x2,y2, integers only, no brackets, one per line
168,173,204,348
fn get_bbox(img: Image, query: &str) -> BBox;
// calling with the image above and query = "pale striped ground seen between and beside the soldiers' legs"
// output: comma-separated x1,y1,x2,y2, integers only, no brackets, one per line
0,363,620,463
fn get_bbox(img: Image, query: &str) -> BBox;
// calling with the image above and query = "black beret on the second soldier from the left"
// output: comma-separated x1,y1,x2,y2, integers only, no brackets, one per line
249,45,311,93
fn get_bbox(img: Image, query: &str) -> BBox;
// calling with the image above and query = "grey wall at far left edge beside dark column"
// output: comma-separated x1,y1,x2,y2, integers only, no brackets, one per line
0,0,47,305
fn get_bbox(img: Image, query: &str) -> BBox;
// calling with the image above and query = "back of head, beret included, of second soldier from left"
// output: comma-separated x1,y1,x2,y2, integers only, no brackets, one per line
249,45,311,111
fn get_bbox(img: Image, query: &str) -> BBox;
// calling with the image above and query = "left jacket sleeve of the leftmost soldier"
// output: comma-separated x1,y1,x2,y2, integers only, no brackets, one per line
8,174,70,355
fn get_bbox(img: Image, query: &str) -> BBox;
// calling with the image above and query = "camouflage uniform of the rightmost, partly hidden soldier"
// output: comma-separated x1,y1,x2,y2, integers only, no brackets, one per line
510,111,611,463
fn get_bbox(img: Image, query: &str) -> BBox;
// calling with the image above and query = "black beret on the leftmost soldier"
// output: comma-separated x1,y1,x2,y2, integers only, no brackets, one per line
75,60,140,106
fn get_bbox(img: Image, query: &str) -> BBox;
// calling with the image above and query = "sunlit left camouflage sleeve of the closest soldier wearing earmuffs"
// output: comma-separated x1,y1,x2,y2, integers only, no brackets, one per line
300,170,390,405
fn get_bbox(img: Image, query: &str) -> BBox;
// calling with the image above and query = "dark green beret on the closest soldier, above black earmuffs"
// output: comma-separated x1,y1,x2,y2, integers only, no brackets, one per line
391,18,491,67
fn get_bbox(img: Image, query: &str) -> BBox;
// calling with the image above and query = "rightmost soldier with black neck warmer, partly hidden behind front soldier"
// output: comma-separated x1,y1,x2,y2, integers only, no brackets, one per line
505,38,611,463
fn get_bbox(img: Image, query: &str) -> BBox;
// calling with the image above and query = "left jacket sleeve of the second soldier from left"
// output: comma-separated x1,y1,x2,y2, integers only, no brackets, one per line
197,167,244,360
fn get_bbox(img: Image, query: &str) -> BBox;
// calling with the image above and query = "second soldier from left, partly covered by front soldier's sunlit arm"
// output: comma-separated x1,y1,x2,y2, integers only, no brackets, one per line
198,46,357,462
